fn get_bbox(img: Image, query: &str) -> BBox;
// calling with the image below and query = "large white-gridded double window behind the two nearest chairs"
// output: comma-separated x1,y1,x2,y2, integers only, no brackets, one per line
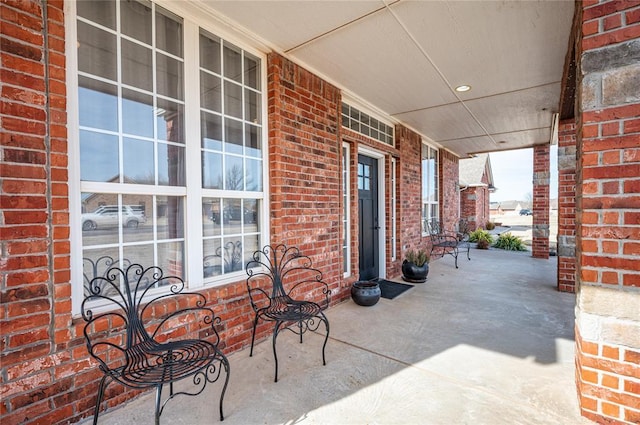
70,0,264,304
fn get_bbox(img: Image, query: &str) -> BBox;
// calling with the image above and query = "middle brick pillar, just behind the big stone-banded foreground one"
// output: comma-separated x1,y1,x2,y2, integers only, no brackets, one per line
558,119,576,293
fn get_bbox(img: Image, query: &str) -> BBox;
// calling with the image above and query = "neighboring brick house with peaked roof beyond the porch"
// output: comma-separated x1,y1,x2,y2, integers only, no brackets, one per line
459,154,495,230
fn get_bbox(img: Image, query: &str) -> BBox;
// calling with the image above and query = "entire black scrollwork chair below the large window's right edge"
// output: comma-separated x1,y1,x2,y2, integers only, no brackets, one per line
246,244,331,382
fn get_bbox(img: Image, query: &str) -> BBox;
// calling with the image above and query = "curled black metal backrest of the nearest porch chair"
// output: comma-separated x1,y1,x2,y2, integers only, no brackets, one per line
81,264,220,367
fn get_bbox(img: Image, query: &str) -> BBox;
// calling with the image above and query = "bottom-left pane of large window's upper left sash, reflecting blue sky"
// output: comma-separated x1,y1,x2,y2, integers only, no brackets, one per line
80,130,120,183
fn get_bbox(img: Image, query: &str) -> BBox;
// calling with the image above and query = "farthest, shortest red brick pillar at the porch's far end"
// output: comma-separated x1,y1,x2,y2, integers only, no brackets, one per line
532,145,550,259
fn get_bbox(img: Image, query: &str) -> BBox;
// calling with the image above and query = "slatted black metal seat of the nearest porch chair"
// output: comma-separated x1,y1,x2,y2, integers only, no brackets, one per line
111,339,217,388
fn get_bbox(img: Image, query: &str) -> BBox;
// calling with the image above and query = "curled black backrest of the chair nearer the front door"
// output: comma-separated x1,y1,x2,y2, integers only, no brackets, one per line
246,244,331,308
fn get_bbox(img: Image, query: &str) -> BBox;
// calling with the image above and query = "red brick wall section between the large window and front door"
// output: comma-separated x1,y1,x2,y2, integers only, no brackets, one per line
267,53,344,298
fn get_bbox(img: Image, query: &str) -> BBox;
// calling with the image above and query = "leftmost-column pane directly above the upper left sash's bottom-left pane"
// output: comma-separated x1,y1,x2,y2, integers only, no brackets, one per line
78,77,118,131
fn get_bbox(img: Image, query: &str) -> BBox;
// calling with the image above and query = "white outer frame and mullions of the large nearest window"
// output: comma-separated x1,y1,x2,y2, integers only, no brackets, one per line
69,0,270,317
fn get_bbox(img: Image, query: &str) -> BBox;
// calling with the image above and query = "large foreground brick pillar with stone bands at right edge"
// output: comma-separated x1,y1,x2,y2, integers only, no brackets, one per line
576,1,640,424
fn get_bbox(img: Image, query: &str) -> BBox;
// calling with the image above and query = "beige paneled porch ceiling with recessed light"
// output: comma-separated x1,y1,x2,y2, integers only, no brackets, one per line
198,0,574,157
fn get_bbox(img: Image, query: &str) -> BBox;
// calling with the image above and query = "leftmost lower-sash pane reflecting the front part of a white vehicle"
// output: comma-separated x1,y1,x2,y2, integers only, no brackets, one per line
81,193,119,242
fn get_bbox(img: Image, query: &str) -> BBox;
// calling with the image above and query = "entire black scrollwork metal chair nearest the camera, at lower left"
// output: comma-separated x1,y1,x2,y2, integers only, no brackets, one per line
82,264,229,425
